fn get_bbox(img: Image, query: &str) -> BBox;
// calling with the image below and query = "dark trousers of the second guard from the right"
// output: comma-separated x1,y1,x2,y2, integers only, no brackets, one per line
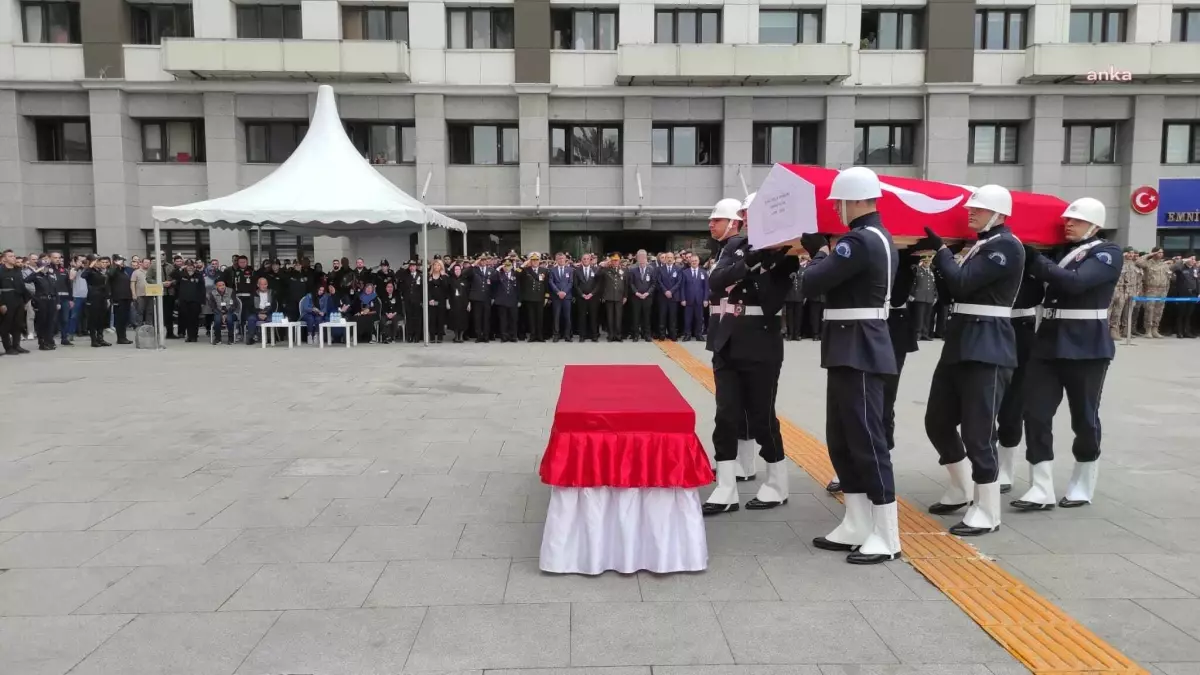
925,362,1013,484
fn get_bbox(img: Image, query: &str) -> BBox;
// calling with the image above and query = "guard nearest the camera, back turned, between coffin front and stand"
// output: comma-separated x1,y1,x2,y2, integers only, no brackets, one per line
800,167,900,565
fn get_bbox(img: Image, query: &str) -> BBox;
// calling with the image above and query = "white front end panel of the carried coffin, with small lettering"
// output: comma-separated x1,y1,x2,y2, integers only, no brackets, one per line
748,165,817,249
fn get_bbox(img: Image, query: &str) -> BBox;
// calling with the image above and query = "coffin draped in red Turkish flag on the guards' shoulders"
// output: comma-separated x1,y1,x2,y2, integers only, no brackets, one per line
750,165,1067,246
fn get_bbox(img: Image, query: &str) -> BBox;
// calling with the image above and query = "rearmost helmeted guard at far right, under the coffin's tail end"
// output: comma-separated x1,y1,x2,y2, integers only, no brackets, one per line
1012,197,1122,510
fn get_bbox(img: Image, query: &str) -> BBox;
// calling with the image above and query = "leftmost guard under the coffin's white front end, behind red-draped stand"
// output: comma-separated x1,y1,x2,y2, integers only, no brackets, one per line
703,199,798,515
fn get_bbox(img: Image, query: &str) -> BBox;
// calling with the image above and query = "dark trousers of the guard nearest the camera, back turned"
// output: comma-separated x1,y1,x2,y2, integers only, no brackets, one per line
826,368,896,504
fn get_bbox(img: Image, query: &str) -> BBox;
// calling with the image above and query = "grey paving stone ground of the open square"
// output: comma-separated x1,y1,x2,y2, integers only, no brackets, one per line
0,341,1200,675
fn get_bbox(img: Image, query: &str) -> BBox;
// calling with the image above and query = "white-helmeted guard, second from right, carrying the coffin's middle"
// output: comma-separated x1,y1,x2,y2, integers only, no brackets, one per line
916,185,1025,537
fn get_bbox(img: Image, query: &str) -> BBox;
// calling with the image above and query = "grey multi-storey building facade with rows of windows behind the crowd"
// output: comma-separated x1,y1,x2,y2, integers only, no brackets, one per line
0,0,1200,264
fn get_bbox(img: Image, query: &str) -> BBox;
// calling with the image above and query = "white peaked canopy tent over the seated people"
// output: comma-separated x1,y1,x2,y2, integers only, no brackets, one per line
151,84,467,346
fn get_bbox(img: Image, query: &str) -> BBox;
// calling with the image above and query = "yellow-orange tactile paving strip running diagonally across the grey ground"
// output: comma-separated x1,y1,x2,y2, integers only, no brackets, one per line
658,342,1150,675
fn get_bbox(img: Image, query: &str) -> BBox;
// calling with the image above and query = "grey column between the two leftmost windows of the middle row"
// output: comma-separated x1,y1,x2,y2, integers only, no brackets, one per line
88,89,142,255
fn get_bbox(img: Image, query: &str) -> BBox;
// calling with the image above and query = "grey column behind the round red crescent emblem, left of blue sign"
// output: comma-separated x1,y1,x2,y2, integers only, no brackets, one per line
1108,96,1166,251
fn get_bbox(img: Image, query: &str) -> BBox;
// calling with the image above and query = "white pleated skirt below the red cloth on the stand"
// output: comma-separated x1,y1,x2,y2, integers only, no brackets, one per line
540,488,708,574
